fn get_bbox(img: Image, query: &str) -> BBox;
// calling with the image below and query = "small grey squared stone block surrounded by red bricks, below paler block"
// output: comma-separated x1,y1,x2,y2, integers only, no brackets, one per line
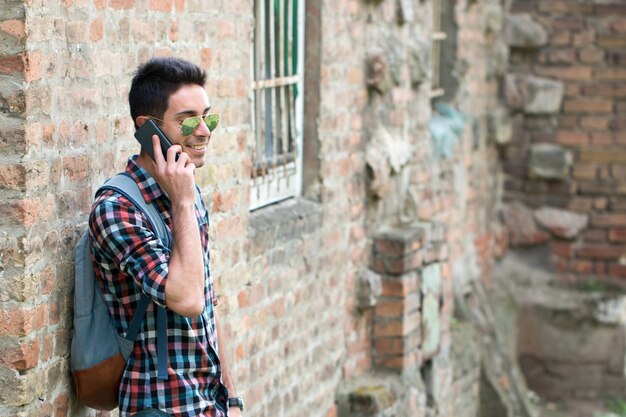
528,143,572,180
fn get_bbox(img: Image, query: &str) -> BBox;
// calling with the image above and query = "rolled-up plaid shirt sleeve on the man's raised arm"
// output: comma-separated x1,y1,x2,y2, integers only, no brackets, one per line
89,194,170,307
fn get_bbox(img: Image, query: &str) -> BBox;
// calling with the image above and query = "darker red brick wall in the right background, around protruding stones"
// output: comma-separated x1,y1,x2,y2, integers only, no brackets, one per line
504,1,626,284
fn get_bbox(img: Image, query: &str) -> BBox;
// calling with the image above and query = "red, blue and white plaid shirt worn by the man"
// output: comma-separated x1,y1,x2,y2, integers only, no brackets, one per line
89,156,228,417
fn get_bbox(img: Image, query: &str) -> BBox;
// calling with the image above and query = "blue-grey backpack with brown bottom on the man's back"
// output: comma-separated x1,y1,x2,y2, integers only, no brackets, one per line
70,173,171,411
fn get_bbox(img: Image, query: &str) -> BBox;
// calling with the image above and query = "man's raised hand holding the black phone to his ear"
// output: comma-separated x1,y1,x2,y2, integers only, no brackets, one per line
152,135,196,210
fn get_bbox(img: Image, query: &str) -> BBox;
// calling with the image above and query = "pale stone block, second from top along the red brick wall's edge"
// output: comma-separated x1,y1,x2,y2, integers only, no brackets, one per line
504,74,564,114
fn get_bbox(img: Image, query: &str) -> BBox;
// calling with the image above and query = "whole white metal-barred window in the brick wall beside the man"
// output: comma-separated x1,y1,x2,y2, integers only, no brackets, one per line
250,0,304,209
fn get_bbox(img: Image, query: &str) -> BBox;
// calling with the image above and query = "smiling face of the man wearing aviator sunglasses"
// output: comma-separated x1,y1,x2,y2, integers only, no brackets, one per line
159,84,211,168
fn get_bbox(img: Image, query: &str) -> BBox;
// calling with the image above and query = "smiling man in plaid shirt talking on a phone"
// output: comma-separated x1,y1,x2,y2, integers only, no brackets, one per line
89,58,243,417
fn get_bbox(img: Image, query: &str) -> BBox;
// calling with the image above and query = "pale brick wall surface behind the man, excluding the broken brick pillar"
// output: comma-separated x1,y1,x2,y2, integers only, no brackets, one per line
0,0,498,417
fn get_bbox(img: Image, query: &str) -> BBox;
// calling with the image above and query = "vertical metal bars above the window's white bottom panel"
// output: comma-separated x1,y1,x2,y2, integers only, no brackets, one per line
252,0,301,192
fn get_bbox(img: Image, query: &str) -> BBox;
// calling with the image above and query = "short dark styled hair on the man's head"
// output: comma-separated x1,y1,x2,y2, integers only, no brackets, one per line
128,57,206,128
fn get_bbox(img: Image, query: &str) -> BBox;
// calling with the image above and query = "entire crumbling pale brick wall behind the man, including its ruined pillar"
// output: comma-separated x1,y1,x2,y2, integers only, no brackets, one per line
0,0,506,417
